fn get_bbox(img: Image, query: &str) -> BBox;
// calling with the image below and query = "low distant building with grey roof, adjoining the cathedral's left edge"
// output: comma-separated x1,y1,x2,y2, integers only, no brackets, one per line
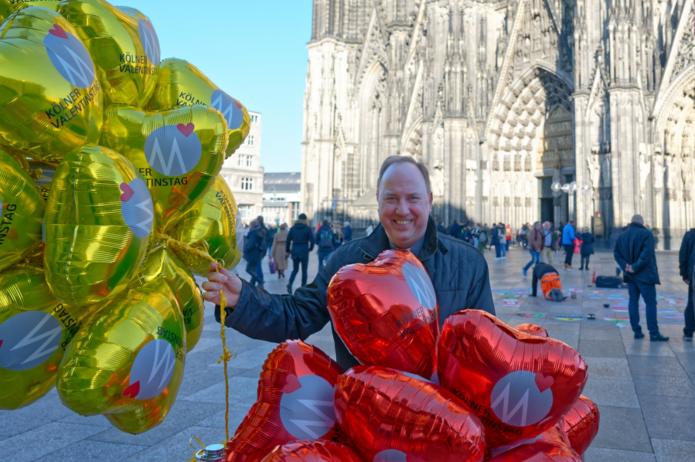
263,172,301,226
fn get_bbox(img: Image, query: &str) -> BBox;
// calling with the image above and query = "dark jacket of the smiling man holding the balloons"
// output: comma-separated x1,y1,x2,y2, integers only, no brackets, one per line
215,220,495,369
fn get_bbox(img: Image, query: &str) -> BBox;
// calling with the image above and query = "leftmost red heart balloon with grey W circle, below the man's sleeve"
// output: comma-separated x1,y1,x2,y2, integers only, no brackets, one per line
227,340,340,462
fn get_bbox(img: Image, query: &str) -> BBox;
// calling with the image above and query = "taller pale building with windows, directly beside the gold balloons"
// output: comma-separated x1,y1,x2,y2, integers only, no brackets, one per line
220,111,263,224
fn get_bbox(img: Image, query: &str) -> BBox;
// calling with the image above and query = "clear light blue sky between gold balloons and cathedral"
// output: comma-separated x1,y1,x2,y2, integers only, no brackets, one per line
115,0,311,172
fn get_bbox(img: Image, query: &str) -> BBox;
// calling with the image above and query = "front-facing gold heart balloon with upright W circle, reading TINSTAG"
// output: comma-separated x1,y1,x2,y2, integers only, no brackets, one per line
101,106,227,230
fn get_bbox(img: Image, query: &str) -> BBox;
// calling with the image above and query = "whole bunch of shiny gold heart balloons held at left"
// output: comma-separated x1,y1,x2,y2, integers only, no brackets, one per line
0,0,250,433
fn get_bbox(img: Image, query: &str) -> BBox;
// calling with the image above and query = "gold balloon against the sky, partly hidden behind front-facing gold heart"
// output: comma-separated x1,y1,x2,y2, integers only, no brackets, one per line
149,58,251,157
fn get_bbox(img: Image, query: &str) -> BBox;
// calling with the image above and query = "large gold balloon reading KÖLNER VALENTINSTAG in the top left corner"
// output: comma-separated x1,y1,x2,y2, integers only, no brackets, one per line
0,6,102,162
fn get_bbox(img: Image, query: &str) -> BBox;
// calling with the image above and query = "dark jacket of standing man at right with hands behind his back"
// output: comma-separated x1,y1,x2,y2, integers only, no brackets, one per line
613,223,660,284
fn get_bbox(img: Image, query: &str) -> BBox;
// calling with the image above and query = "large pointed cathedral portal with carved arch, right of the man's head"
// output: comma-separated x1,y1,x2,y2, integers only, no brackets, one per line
487,66,575,226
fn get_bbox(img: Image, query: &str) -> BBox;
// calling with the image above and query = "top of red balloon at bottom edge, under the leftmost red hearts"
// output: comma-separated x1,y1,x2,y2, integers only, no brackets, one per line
261,441,362,462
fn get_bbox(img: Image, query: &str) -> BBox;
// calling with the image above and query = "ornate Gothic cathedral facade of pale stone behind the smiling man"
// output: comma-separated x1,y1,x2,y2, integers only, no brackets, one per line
302,0,695,248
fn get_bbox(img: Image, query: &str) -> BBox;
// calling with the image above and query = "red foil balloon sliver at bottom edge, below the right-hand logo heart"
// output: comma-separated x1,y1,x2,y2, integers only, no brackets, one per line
488,426,582,462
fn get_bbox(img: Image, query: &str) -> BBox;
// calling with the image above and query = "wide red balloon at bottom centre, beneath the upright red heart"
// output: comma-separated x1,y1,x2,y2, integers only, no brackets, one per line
335,366,485,462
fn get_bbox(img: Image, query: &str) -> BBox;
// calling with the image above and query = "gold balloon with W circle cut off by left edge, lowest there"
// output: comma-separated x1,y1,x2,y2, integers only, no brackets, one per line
0,266,80,409
